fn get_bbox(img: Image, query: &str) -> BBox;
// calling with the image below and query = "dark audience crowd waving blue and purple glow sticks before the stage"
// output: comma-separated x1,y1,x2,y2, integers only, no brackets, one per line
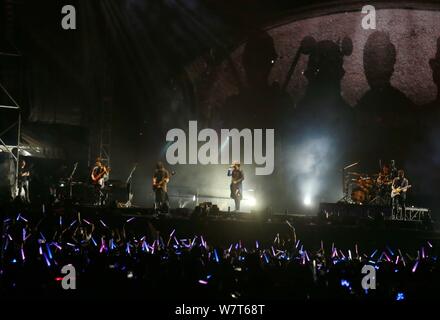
0,204,440,301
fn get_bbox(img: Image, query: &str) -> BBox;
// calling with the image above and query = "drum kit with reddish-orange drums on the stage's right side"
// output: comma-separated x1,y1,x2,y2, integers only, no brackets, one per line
346,172,392,206
